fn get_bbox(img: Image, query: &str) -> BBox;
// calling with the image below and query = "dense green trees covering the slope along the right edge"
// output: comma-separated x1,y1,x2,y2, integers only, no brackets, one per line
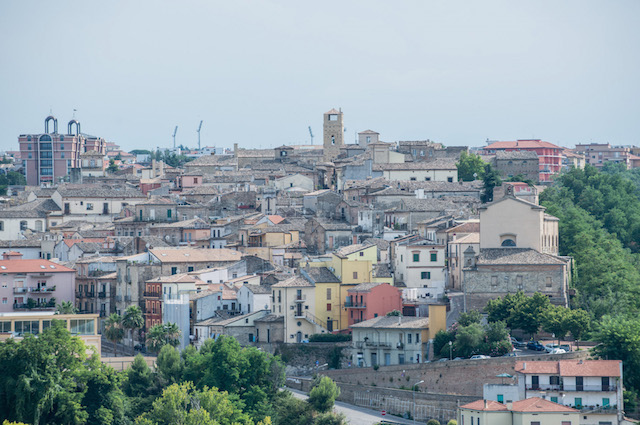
540,164,640,391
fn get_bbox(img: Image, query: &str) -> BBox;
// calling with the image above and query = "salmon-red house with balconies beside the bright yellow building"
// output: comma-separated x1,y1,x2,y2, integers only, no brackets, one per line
345,282,402,326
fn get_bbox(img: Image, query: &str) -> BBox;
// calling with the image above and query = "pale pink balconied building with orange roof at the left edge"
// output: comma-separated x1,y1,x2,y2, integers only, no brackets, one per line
0,252,76,313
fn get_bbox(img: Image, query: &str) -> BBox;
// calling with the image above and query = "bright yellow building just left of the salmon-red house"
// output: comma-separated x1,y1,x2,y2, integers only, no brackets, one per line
304,244,393,331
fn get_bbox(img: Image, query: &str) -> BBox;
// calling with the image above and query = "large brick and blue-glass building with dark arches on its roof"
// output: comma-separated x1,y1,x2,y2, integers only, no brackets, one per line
18,115,106,186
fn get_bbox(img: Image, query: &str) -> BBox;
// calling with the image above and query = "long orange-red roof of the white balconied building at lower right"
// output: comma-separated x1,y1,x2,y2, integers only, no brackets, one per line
515,360,621,377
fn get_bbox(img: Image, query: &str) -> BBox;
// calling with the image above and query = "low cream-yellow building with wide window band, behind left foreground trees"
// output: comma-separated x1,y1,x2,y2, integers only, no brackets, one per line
0,311,102,355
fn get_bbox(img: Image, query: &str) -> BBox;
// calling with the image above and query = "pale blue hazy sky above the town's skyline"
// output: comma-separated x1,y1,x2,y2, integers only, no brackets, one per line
0,0,640,150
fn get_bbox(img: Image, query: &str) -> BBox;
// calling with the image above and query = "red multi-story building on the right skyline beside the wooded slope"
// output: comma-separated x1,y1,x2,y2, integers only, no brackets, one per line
483,139,564,183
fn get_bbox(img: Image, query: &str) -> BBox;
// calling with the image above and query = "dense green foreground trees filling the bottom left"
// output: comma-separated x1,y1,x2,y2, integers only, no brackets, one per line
0,322,344,425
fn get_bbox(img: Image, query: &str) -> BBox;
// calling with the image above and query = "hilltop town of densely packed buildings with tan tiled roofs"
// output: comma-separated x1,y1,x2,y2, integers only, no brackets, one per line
0,109,640,425
